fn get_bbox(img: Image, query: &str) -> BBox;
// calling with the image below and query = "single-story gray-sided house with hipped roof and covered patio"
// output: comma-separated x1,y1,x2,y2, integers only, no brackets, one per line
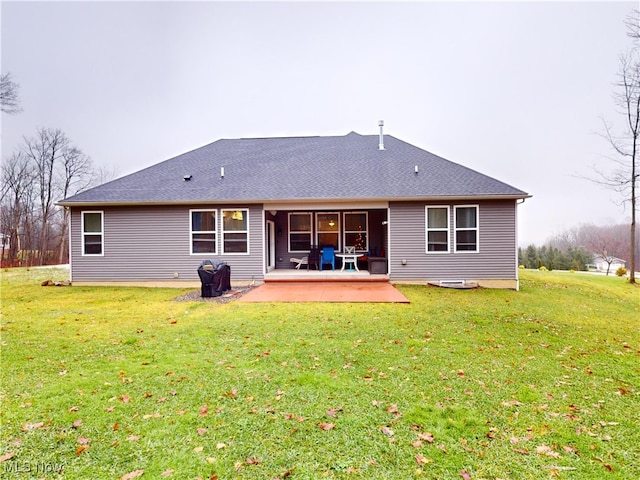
59,126,530,289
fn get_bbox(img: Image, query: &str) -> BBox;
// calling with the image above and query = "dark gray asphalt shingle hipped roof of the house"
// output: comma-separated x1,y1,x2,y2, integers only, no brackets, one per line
60,132,529,205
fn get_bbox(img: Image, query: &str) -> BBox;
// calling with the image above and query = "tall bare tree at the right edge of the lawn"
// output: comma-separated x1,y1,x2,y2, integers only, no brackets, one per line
596,10,640,283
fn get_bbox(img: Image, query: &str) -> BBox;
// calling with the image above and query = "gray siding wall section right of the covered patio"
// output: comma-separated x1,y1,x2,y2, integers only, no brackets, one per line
389,200,517,281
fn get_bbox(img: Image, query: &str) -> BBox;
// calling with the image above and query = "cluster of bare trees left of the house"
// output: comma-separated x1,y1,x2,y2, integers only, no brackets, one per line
0,128,99,266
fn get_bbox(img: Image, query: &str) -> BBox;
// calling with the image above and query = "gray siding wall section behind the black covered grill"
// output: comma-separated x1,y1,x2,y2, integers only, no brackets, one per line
71,205,263,282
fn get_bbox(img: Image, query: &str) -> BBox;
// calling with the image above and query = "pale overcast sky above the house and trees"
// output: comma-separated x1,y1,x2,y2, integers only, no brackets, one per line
0,0,638,245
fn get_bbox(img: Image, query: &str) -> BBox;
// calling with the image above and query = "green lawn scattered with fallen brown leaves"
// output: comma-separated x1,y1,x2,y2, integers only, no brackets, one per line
0,269,640,480
